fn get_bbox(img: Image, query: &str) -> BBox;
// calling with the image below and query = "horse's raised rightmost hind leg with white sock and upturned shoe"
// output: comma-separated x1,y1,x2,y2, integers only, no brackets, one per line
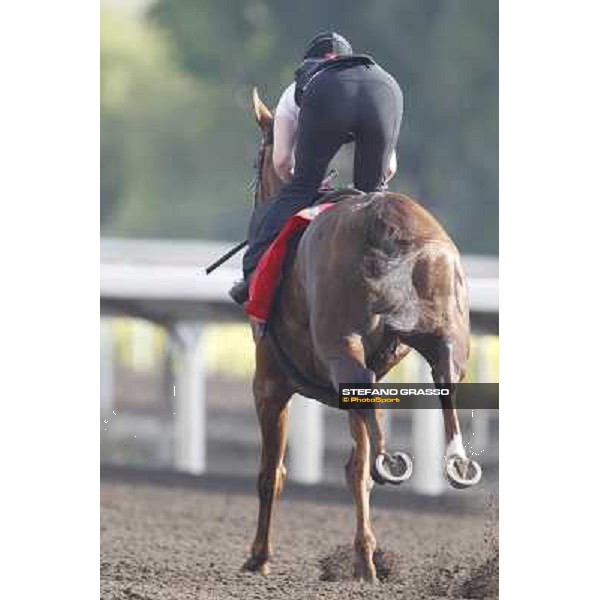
423,337,481,489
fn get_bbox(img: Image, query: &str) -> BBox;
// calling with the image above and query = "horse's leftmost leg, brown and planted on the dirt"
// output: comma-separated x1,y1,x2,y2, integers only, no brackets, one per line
243,341,291,575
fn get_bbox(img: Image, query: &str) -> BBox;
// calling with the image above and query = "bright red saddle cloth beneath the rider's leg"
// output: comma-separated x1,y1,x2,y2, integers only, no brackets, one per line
246,202,335,323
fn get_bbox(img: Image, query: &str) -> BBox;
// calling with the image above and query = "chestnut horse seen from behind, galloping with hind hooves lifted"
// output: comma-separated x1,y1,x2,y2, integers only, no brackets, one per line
243,88,481,582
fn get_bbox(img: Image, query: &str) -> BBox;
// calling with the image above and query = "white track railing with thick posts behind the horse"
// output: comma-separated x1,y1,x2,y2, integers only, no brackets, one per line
100,240,498,494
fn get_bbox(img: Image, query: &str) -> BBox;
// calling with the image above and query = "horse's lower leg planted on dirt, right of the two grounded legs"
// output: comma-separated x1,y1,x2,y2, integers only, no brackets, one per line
346,410,377,582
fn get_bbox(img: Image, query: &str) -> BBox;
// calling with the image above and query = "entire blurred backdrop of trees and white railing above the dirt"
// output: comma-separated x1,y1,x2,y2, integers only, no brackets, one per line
100,0,498,494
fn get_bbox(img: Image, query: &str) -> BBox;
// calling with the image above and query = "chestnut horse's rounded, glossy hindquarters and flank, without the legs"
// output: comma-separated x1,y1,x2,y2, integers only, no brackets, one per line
274,194,469,389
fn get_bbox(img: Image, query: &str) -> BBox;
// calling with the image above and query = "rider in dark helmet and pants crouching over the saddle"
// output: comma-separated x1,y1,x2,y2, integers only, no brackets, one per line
229,32,403,304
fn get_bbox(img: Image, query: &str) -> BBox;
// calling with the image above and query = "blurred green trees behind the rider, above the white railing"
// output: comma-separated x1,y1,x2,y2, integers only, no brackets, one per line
101,0,498,255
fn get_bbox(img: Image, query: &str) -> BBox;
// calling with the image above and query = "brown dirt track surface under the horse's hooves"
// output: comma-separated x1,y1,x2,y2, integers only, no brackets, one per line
101,480,498,600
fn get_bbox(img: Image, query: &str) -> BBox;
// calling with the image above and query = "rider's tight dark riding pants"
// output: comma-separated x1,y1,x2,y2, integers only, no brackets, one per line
244,65,403,277
